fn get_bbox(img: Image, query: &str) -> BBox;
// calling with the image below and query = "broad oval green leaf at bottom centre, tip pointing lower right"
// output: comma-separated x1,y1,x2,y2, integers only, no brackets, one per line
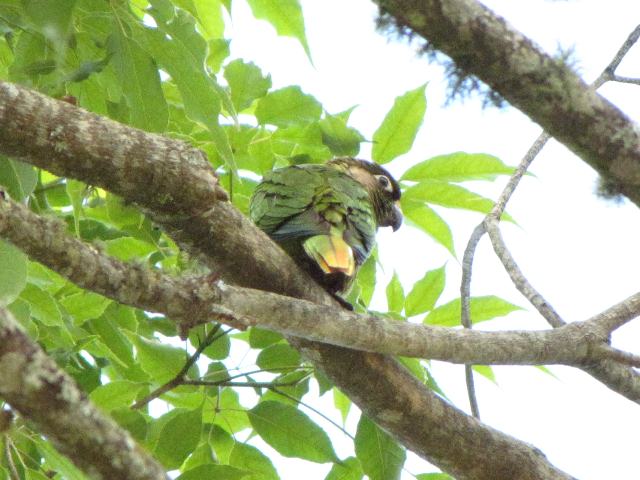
248,401,338,463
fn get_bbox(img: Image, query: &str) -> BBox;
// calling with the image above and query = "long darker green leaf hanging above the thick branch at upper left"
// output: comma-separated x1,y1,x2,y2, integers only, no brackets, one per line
110,31,169,132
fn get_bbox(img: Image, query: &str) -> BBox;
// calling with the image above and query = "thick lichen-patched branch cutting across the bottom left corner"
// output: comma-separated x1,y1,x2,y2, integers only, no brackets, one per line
0,308,168,480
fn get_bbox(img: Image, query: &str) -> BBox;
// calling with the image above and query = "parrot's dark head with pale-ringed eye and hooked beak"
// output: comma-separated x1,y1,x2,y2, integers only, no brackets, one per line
329,157,402,231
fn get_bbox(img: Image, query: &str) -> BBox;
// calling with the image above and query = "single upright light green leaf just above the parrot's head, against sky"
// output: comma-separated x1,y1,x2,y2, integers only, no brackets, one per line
371,84,427,164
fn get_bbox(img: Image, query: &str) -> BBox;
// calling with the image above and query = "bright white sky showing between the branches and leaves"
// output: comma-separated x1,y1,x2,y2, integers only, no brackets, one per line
224,0,640,480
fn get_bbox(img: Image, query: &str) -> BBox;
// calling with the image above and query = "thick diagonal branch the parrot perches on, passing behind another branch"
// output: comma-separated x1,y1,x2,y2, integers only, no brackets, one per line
0,83,569,480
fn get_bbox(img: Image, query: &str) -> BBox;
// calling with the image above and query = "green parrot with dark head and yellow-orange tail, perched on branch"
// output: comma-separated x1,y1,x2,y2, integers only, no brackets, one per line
249,157,402,296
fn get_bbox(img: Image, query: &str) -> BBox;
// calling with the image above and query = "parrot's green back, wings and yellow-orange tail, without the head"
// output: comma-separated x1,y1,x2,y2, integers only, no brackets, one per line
250,165,377,292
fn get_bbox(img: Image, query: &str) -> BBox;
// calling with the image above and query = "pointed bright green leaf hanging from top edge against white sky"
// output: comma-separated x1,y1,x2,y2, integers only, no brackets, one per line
247,0,311,61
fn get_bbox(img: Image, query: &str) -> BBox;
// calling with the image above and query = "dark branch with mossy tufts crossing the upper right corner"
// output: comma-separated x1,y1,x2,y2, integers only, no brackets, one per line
374,0,640,205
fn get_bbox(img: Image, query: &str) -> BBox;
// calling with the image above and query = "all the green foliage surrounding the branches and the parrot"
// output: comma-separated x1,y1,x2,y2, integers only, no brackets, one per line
0,0,518,480
